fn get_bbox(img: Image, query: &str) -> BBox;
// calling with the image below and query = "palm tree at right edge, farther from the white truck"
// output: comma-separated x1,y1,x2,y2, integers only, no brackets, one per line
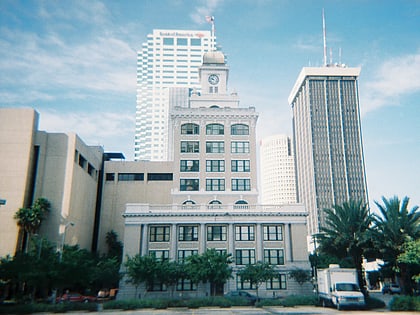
374,196,420,296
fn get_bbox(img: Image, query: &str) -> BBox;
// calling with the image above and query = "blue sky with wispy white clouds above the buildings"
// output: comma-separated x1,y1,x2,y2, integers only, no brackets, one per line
0,0,420,212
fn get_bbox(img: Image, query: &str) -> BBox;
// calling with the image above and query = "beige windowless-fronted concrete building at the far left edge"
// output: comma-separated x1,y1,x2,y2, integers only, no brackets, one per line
0,108,103,256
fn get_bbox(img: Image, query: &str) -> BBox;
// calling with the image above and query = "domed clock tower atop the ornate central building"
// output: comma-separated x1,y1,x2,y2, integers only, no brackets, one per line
190,51,239,108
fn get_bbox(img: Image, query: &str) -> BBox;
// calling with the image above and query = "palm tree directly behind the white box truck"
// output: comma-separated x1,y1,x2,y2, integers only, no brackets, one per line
316,200,373,289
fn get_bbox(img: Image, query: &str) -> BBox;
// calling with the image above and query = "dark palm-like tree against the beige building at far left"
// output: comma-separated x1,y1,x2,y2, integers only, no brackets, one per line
14,198,51,251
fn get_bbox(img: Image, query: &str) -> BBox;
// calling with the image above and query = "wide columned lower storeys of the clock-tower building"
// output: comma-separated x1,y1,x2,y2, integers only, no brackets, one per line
118,204,312,299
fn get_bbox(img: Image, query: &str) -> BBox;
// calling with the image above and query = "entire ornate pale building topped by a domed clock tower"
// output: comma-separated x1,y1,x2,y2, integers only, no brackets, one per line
119,51,312,298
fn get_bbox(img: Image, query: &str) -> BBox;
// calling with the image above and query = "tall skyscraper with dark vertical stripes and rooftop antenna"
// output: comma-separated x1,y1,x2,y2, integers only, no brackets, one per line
289,65,368,235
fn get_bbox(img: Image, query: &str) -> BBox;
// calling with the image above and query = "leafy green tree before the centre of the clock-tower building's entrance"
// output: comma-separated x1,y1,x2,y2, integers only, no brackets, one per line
185,248,233,296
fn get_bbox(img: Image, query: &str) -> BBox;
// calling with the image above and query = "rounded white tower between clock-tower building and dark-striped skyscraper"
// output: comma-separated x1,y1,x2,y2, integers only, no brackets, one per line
260,135,296,204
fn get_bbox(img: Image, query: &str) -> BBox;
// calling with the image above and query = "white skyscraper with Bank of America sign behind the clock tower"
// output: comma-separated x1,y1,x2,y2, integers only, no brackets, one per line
134,30,214,161
